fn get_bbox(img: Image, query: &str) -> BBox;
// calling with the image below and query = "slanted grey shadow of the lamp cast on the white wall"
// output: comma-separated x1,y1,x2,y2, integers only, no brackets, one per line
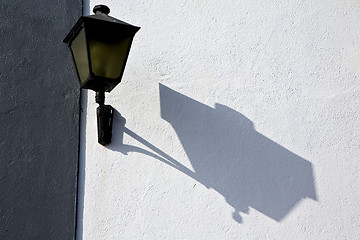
109,84,317,223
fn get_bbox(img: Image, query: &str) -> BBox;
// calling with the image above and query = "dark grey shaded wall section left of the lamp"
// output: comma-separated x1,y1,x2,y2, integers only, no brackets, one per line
0,0,82,239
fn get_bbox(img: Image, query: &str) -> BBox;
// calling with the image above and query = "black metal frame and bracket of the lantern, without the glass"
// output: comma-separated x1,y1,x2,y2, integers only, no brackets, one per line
63,5,140,145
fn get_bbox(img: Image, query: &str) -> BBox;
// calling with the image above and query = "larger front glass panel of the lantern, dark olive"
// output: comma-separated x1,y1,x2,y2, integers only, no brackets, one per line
89,36,132,79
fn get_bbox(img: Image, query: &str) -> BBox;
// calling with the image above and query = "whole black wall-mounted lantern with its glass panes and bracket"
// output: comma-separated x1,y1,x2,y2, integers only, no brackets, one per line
63,5,140,145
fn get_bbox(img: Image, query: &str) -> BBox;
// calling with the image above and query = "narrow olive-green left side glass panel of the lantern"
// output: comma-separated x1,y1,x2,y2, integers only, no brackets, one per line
71,28,89,83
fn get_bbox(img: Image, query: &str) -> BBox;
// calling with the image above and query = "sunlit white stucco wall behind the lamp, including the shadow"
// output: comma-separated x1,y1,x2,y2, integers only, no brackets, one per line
78,0,360,239
